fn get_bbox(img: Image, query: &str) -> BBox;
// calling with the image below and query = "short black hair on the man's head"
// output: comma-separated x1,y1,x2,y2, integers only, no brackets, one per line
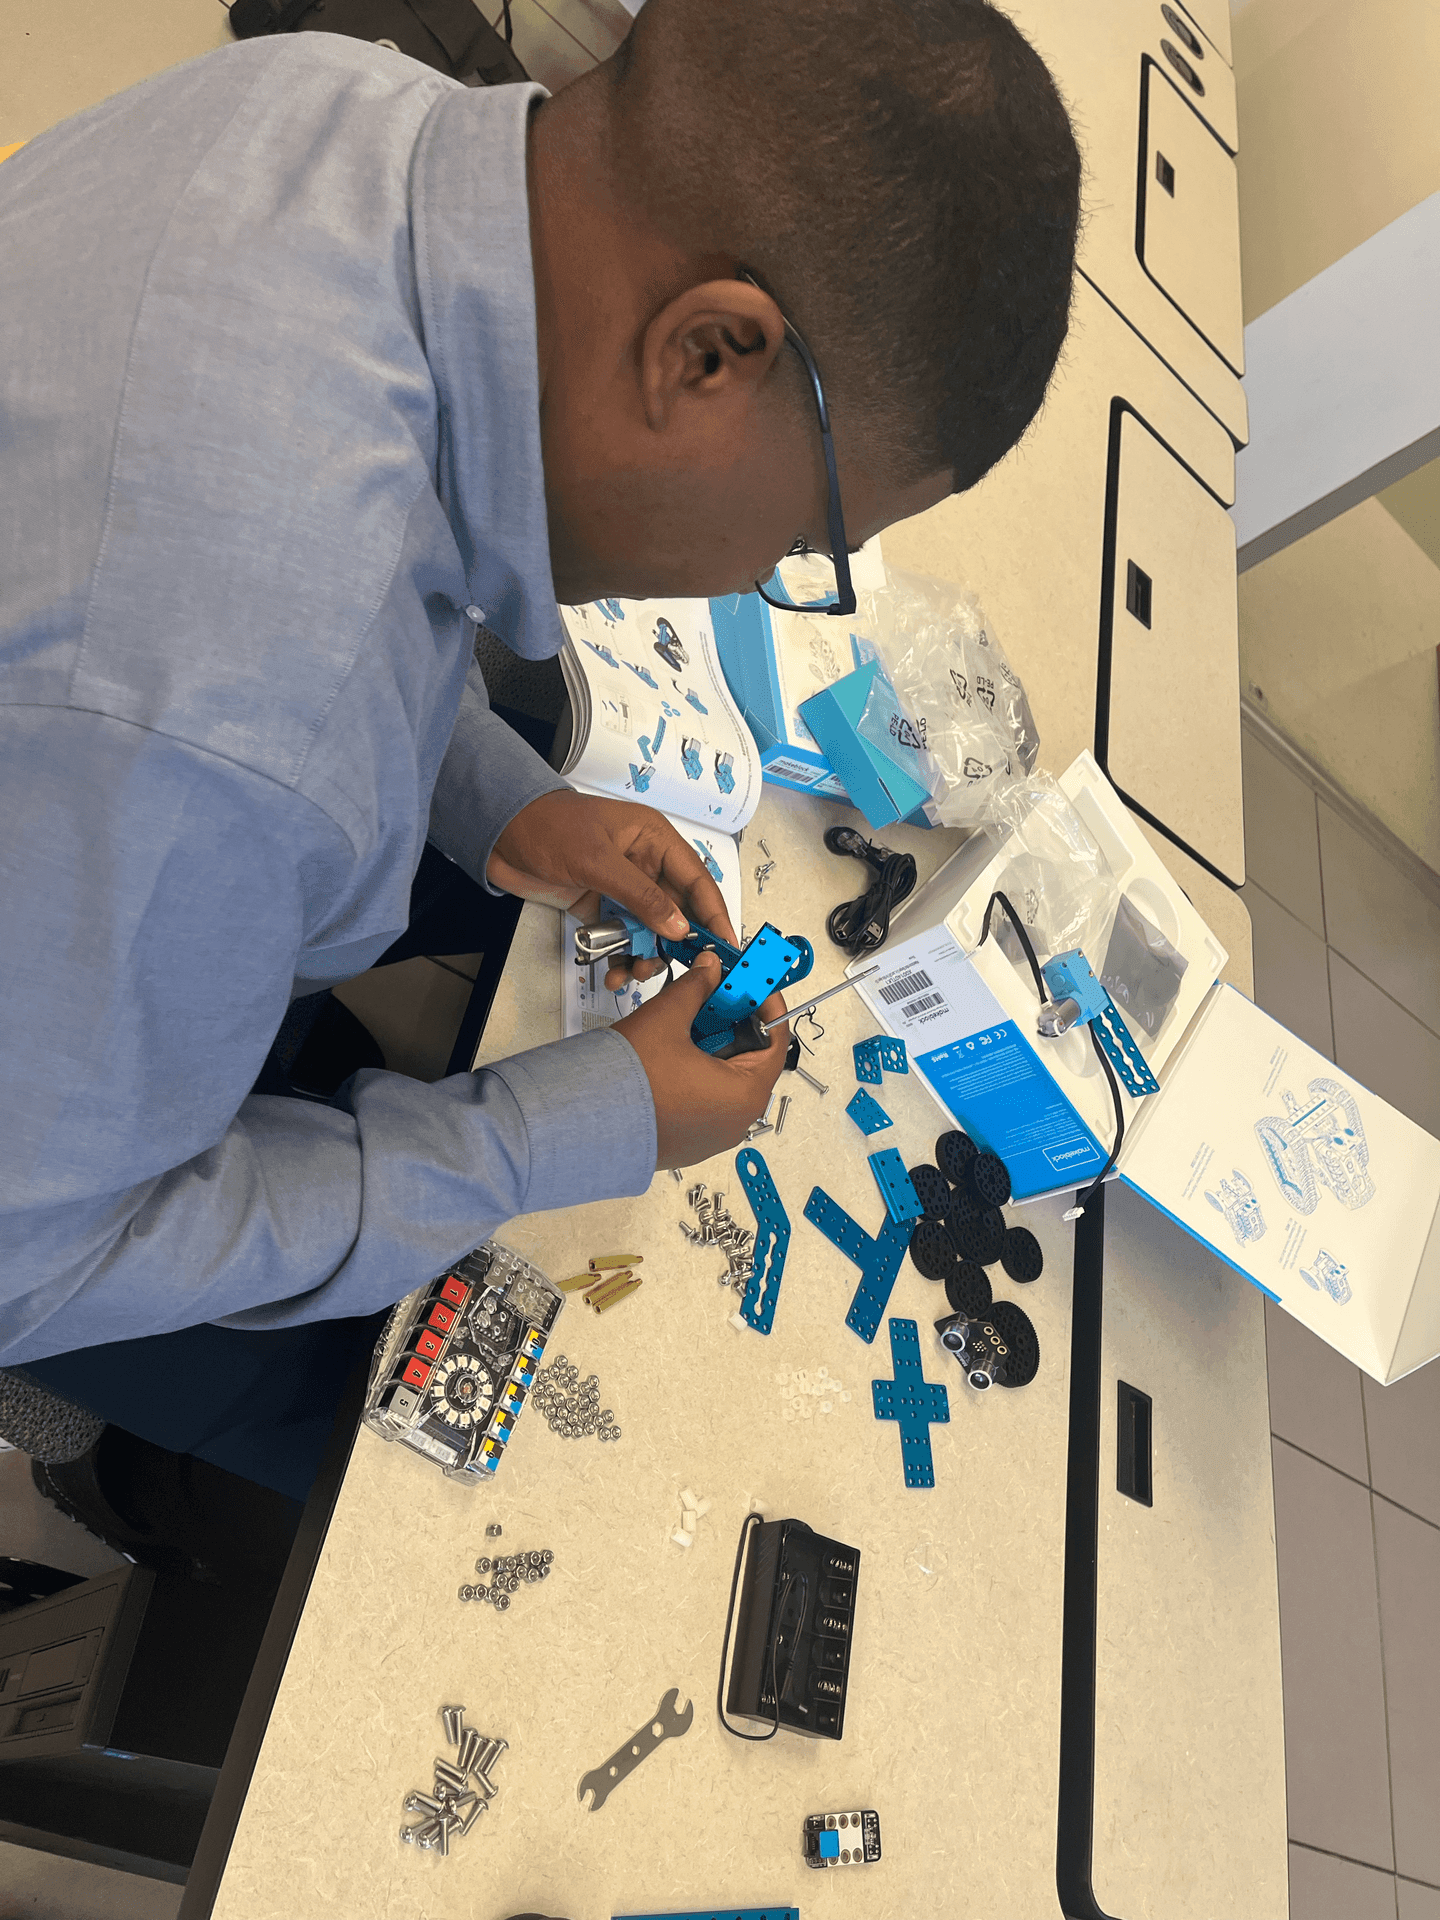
612,0,1081,492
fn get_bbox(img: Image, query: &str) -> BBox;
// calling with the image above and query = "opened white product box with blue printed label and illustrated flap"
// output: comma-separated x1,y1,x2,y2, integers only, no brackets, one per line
852,753,1440,1380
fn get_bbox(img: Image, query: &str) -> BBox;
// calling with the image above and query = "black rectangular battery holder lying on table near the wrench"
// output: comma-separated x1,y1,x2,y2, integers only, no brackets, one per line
726,1521,860,1740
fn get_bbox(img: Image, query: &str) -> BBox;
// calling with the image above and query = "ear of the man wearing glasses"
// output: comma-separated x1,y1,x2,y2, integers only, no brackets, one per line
639,280,785,432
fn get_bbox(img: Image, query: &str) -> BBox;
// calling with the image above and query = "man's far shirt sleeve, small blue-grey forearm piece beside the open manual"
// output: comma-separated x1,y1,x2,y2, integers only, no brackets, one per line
430,645,568,893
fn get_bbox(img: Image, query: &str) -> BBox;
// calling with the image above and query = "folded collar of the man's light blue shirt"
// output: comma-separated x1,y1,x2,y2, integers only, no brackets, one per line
415,86,564,660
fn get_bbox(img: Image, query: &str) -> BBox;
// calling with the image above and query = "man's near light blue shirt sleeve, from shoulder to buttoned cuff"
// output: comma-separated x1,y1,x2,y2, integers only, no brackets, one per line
0,708,655,1363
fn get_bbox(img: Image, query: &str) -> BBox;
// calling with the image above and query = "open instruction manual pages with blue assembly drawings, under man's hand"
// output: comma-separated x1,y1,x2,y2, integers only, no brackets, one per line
561,599,762,1035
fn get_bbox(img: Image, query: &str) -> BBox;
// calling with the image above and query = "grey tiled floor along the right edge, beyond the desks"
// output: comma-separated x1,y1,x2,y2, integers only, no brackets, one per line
1244,730,1440,1920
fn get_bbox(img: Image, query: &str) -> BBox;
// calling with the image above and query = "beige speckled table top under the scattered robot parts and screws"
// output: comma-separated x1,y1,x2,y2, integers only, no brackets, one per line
200,764,1279,1920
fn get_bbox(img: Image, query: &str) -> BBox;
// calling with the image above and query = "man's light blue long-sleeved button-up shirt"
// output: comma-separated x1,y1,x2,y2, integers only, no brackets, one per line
0,35,655,1363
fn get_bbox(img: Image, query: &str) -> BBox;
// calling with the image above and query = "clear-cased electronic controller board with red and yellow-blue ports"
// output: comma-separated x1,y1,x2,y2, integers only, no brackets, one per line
365,1240,564,1482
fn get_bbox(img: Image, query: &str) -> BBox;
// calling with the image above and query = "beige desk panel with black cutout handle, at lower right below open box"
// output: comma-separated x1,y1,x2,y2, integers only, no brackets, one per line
1066,1183,1288,1920
